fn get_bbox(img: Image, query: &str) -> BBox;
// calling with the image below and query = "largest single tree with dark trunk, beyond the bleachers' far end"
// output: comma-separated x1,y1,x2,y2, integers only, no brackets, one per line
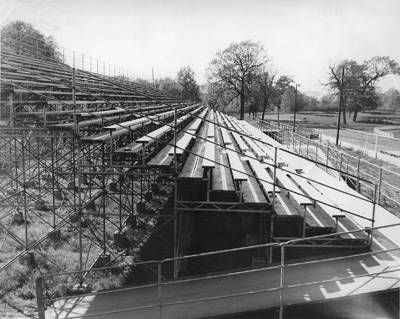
208,41,267,119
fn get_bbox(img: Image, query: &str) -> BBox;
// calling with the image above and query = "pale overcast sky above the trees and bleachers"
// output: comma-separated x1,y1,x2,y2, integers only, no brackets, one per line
0,0,400,96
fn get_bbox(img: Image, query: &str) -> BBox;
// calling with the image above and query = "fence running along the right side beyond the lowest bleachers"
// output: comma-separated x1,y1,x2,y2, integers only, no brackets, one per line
259,121,400,215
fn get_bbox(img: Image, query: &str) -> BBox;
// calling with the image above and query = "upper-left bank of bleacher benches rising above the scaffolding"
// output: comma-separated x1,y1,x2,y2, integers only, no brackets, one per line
1,47,188,124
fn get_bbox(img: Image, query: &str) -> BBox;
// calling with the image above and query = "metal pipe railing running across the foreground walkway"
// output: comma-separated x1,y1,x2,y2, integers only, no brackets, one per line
36,223,400,319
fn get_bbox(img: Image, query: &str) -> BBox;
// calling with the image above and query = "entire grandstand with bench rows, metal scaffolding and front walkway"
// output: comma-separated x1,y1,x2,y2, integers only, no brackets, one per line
0,38,400,318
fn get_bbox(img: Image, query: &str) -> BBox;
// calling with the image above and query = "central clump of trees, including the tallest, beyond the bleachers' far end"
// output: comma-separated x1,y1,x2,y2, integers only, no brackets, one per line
206,41,318,119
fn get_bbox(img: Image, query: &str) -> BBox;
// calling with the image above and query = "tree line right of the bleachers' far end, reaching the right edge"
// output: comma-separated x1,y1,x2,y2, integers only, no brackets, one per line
205,41,400,123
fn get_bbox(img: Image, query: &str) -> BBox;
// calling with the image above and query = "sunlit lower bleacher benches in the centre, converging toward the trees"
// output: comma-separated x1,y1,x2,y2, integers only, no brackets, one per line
142,109,365,238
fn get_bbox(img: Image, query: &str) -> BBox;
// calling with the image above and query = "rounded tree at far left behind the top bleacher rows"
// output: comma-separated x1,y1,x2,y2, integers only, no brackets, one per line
1,21,61,61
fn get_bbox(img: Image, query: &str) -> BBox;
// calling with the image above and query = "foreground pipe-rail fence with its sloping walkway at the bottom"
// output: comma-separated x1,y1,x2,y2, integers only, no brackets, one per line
36,223,400,319
